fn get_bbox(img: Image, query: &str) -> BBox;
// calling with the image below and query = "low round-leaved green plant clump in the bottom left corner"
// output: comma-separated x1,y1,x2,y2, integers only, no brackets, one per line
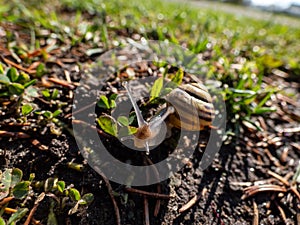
0,168,94,225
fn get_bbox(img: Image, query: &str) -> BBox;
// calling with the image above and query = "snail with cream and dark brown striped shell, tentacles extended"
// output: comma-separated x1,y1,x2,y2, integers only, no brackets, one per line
121,79,214,154
